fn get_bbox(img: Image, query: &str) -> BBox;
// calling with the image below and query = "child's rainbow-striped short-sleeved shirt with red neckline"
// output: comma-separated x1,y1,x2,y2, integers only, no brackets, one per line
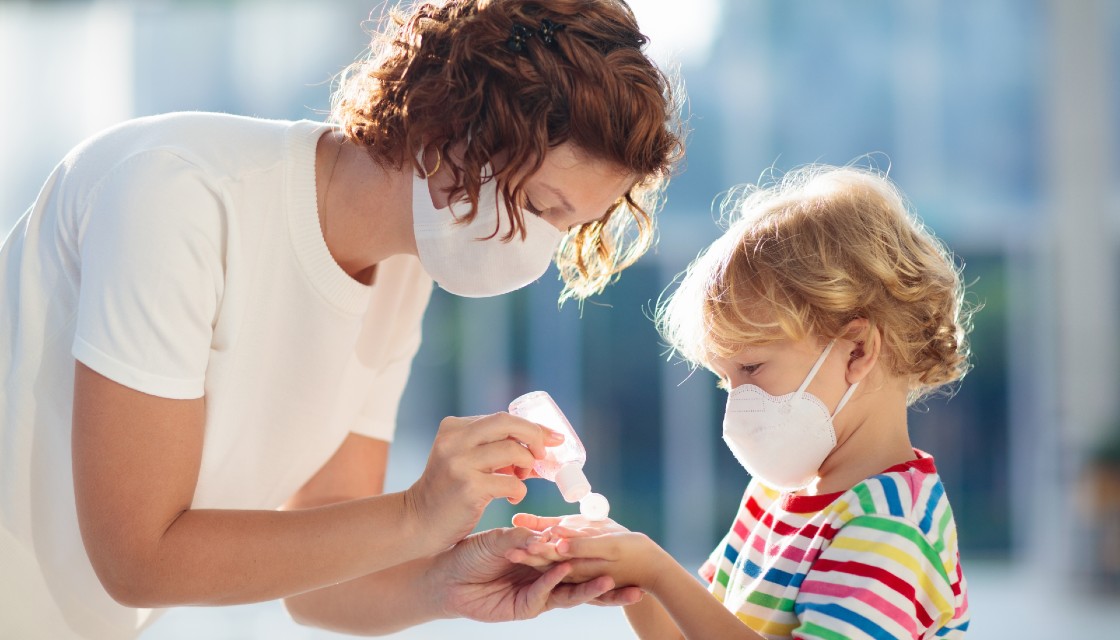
700,449,969,640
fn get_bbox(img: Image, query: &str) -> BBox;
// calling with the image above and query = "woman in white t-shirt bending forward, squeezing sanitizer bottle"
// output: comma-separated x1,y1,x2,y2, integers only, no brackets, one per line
0,0,681,638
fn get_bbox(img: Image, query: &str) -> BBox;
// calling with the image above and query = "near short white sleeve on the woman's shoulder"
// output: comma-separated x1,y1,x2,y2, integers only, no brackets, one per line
73,151,225,399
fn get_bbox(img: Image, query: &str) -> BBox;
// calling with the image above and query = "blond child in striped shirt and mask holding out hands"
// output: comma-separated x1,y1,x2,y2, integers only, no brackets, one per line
507,166,971,640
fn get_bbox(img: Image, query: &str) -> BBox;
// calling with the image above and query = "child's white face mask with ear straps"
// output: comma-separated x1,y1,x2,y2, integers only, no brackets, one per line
724,341,859,491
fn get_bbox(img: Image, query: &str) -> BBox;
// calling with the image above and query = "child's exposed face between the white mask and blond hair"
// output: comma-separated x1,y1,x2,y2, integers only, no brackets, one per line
711,336,853,408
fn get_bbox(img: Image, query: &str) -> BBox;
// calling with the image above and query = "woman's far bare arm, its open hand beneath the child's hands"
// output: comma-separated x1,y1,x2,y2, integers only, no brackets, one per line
284,421,640,634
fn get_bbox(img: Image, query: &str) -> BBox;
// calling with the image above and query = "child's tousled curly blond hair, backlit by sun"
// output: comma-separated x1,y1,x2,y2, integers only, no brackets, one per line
656,165,976,402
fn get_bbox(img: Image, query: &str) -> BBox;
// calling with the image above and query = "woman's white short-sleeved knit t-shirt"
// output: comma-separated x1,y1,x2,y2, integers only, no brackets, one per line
0,113,431,639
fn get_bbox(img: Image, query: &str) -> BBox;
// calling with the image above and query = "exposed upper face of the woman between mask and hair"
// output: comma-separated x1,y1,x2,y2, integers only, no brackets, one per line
521,142,636,231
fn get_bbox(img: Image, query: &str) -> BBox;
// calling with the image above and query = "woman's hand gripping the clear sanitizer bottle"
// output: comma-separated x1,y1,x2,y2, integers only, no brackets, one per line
404,412,563,551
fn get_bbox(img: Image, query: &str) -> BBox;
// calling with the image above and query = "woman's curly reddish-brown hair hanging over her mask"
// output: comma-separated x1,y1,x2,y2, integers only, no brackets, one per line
332,0,683,302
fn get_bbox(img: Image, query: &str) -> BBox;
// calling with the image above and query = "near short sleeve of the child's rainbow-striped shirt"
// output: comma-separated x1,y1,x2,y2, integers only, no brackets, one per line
792,516,955,639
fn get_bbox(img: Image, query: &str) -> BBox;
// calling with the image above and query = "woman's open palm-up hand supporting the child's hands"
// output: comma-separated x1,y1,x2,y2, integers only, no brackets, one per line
428,528,642,622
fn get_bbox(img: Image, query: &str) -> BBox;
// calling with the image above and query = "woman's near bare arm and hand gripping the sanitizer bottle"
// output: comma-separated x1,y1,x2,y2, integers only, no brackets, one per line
73,363,555,606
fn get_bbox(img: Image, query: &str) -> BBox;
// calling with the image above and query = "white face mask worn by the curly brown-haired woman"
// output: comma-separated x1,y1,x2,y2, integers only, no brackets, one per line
412,168,564,298
